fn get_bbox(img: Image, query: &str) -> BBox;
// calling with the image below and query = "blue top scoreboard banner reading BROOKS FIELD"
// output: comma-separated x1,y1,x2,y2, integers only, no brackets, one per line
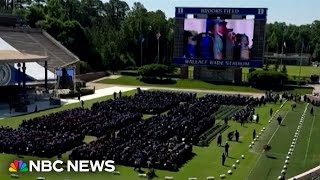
176,7,268,18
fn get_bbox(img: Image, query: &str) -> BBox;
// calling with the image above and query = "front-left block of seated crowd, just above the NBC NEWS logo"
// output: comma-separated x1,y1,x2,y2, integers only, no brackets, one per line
0,127,84,158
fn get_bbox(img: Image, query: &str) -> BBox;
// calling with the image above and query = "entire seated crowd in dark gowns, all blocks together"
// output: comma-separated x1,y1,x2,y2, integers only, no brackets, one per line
0,91,265,171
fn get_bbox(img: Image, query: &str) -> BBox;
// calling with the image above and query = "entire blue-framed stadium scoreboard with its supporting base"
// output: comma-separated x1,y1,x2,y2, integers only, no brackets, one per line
173,7,267,81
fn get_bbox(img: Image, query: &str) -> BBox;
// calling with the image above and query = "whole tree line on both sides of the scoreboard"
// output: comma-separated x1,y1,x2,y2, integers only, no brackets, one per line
0,0,320,72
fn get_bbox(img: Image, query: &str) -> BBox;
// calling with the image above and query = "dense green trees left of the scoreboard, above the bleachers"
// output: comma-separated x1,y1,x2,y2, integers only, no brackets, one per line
2,0,174,71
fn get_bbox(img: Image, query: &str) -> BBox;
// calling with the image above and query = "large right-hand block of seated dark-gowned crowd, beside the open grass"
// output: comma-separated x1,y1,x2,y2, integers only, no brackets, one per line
70,94,260,171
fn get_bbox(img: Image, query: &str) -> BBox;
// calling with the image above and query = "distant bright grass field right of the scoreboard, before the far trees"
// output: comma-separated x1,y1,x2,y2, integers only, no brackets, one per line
242,65,320,77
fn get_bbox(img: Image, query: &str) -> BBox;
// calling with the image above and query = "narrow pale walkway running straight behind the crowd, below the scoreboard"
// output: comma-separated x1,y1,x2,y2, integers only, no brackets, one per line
87,82,264,97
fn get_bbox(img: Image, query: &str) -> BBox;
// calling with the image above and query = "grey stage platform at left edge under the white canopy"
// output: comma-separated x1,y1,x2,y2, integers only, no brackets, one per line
0,99,63,120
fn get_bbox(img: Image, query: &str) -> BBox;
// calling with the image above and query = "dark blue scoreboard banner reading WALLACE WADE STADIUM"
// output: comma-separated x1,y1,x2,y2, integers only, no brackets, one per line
172,57,263,68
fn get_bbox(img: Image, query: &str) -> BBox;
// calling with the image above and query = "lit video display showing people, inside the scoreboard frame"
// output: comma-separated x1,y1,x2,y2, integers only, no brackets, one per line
184,19,254,60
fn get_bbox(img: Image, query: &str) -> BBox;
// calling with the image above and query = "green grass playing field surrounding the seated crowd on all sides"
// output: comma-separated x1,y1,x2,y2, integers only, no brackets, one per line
0,91,320,180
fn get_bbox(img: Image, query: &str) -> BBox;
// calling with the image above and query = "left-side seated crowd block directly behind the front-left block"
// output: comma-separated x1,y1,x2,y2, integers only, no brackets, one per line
20,108,142,137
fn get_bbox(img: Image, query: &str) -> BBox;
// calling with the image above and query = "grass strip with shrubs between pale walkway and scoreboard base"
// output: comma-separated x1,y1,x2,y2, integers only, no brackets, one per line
98,76,312,94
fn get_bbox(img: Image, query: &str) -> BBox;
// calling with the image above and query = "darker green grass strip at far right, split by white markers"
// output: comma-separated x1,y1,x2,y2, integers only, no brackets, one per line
248,103,320,180
